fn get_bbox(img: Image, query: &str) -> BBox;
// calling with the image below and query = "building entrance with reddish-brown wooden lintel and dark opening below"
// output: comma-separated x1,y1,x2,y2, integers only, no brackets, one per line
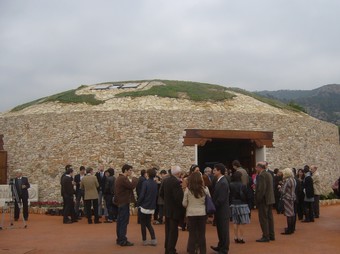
183,129,273,173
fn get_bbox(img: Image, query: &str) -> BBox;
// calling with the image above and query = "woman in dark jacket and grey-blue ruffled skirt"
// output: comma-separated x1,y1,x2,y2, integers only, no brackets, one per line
230,171,250,243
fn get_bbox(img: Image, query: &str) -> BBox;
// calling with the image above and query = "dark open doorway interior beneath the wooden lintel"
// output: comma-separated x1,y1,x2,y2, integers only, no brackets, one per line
197,139,255,173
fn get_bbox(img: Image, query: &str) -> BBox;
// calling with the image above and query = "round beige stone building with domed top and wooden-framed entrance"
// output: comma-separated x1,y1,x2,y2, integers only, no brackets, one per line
0,82,340,201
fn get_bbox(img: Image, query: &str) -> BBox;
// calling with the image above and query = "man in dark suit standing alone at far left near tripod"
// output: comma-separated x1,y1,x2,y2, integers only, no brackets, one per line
13,169,30,221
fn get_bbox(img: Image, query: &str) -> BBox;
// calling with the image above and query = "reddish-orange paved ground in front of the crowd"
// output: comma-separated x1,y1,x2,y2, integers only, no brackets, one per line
0,205,340,254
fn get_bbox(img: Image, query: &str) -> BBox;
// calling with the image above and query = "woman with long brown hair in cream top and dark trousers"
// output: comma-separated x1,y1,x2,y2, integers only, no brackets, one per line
182,172,210,254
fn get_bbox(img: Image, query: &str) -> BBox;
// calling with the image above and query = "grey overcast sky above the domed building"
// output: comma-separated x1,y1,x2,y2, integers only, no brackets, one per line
0,0,340,112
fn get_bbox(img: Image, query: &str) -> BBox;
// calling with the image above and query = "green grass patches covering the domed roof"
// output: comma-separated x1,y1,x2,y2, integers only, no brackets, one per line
11,80,304,112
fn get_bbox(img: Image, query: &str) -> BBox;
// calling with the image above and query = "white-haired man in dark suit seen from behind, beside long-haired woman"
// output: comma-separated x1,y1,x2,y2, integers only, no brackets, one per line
160,166,185,254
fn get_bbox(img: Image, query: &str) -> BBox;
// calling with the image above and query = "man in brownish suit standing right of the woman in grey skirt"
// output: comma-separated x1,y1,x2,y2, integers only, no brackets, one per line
255,162,275,242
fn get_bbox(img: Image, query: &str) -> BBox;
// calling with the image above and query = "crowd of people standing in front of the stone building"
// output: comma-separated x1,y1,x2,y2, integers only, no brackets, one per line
10,160,339,254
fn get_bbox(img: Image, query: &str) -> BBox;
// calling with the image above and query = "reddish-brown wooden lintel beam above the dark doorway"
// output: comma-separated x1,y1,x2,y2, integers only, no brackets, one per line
183,129,274,148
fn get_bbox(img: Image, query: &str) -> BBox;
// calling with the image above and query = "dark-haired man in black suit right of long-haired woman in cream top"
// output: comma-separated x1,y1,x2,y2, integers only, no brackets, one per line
211,163,230,254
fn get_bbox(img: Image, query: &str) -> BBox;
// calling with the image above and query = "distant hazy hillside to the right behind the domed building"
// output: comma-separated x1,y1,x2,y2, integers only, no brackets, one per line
254,84,340,125
